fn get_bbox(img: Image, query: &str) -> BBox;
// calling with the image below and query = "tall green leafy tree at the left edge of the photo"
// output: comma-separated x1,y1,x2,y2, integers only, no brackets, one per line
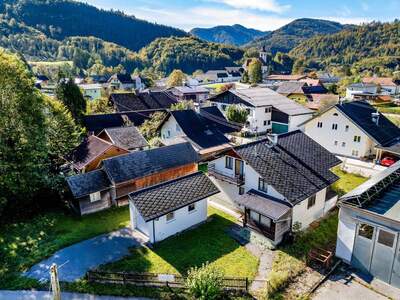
0,50,48,213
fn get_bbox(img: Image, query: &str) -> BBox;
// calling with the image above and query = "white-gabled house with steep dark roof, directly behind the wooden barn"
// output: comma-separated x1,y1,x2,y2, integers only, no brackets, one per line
160,107,241,159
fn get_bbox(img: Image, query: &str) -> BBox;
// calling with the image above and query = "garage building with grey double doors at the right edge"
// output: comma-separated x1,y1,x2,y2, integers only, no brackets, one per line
336,163,400,288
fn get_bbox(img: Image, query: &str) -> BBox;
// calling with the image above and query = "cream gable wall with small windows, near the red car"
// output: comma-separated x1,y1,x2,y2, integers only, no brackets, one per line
305,108,375,158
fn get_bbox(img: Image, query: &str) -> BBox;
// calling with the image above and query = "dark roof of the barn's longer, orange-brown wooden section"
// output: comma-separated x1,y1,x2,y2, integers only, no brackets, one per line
103,143,198,183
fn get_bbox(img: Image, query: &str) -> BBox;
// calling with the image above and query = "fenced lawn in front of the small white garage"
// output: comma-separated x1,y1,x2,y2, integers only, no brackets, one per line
102,208,258,279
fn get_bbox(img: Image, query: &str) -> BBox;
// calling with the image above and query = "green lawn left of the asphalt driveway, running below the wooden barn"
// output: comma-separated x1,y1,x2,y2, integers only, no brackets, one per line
0,207,129,289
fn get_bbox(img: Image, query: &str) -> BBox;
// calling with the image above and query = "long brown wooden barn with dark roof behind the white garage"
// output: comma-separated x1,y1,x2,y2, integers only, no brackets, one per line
67,143,198,215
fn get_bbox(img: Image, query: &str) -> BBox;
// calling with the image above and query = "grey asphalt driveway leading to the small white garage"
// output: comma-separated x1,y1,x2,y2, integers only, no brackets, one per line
24,228,146,282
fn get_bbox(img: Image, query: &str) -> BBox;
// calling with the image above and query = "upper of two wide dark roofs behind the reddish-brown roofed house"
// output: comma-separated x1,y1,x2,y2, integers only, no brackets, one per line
109,90,178,112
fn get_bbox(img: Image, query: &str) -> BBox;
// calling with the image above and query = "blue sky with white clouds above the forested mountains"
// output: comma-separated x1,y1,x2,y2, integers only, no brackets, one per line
82,0,400,30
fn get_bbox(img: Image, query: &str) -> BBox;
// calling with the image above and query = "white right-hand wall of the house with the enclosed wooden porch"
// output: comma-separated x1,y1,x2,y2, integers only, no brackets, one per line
292,189,326,229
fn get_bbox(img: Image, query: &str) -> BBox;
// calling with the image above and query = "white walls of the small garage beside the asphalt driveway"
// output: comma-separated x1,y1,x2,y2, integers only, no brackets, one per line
130,199,207,243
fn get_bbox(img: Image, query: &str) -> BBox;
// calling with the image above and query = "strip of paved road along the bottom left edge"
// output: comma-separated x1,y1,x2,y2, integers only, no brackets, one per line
0,291,153,300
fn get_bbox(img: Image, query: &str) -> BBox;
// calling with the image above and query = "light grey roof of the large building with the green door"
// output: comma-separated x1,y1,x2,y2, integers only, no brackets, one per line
229,87,313,116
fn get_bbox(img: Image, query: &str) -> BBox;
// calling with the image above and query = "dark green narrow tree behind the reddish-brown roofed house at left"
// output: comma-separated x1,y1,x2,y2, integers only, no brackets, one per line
56,78,86,124
